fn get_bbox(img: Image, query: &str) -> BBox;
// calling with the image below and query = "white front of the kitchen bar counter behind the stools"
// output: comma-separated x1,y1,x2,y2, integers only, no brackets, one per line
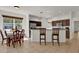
31,28,66,42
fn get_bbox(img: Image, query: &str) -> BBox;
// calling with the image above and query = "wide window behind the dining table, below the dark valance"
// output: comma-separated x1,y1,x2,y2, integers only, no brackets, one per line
3,17,22,29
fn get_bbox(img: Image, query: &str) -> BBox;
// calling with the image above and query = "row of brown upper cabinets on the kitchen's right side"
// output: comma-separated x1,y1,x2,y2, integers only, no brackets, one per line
52,19,70,26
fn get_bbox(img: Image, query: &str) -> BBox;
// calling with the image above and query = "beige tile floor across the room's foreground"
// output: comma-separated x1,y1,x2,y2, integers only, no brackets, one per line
0,34,79,53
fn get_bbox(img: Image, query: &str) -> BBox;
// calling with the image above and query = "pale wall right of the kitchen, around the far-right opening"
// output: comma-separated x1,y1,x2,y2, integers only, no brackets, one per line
70,12,79,39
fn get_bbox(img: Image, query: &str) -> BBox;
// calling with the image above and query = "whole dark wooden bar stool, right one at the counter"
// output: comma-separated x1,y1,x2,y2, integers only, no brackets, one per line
52,28,60,46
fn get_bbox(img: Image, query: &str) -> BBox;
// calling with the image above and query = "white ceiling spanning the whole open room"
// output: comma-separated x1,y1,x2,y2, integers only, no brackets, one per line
0,6,79,17
